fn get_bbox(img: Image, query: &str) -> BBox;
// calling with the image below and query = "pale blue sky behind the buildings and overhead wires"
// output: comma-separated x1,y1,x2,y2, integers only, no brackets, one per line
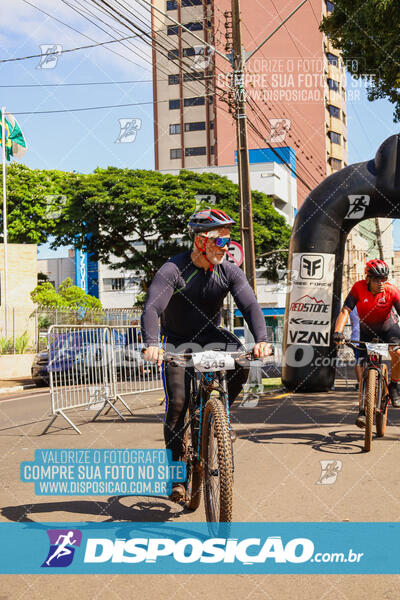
0,0,400,258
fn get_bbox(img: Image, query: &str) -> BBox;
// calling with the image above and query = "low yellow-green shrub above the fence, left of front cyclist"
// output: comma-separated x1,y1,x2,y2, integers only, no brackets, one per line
31,277,101,310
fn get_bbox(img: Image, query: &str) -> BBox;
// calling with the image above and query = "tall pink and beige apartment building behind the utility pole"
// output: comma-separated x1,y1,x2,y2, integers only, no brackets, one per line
152,0,347,206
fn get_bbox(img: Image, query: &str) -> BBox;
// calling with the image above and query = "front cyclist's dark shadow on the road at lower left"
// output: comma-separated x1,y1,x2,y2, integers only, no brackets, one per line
1,496,183,523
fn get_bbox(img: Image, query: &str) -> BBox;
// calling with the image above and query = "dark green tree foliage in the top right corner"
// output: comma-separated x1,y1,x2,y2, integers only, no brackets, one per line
321,0,400,121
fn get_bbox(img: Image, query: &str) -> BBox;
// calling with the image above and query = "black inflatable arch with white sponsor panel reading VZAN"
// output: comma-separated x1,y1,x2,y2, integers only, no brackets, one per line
282,135,400,392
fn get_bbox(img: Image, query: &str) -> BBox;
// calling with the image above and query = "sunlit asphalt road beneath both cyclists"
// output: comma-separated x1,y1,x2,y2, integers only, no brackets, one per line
0,382,400,600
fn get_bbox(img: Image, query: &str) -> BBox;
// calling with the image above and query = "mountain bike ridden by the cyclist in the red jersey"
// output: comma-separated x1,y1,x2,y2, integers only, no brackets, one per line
345,340,394,452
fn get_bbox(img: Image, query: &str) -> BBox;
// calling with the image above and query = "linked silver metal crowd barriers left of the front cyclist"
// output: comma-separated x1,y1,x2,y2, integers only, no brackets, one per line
43,325,163,433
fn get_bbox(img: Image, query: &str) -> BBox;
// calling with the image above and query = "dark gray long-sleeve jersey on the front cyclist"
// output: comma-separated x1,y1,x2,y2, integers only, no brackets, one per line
141,252,267,346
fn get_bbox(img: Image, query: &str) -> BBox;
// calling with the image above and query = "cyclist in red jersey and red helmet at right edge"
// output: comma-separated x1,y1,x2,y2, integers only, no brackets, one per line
333,259,400,427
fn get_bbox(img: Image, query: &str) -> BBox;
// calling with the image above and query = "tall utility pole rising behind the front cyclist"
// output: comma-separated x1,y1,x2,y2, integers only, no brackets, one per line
232,0,257,293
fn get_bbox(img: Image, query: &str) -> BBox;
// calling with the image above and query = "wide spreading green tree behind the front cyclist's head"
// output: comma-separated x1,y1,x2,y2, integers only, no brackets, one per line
54,167,290,290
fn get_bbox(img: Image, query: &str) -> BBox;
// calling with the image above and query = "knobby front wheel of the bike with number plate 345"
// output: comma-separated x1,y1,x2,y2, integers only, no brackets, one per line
201,398,233,523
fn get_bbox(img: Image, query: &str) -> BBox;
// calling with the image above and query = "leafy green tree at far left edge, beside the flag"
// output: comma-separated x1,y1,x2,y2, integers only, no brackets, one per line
0,162,72,244
